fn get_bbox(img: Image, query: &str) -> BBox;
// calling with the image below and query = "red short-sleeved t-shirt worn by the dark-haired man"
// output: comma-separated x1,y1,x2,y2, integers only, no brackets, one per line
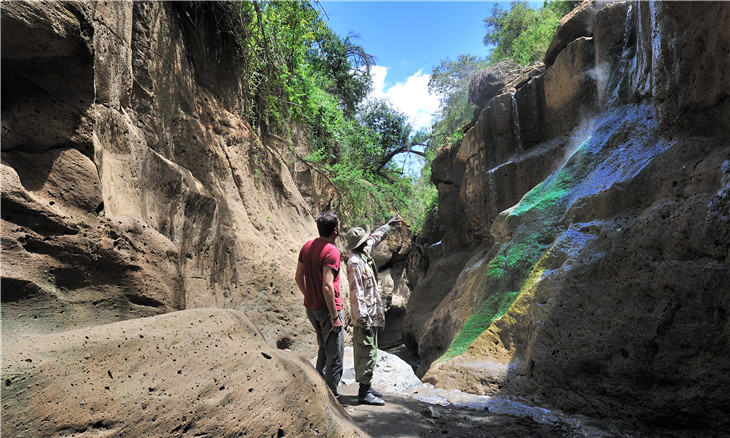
299,238,342,310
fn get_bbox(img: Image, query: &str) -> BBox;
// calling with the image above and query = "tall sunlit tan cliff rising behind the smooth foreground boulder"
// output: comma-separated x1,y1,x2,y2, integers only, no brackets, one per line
2,2,322,352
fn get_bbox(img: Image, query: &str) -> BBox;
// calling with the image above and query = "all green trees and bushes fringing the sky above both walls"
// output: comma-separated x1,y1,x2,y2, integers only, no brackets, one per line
177,0,577,232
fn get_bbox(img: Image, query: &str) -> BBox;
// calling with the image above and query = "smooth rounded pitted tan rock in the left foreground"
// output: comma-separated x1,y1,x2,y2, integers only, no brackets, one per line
2,309,367,437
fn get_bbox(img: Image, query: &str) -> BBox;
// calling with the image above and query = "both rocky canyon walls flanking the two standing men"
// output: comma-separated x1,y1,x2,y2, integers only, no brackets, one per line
1,0,730,437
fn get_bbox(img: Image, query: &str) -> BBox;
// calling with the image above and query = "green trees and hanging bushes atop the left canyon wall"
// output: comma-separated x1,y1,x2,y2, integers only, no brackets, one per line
180,0,436,236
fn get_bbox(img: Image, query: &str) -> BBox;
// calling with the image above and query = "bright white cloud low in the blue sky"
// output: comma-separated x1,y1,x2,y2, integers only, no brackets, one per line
370,65,439,130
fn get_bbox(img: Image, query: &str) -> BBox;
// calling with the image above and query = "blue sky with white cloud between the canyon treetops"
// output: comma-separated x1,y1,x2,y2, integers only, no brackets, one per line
320,0,509,128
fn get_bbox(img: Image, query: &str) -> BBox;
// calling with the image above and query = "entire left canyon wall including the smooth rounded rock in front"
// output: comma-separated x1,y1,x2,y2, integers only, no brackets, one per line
1,1,370,436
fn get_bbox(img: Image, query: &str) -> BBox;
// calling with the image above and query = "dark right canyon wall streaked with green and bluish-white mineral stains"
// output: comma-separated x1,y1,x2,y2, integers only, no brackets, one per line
404,2,730,429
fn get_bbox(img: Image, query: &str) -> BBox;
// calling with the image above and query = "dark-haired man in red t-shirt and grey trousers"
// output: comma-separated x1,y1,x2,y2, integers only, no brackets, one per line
295,211,345,397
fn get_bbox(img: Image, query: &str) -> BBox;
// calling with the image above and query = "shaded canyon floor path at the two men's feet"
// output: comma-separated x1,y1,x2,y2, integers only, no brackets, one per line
332,346,656,438
